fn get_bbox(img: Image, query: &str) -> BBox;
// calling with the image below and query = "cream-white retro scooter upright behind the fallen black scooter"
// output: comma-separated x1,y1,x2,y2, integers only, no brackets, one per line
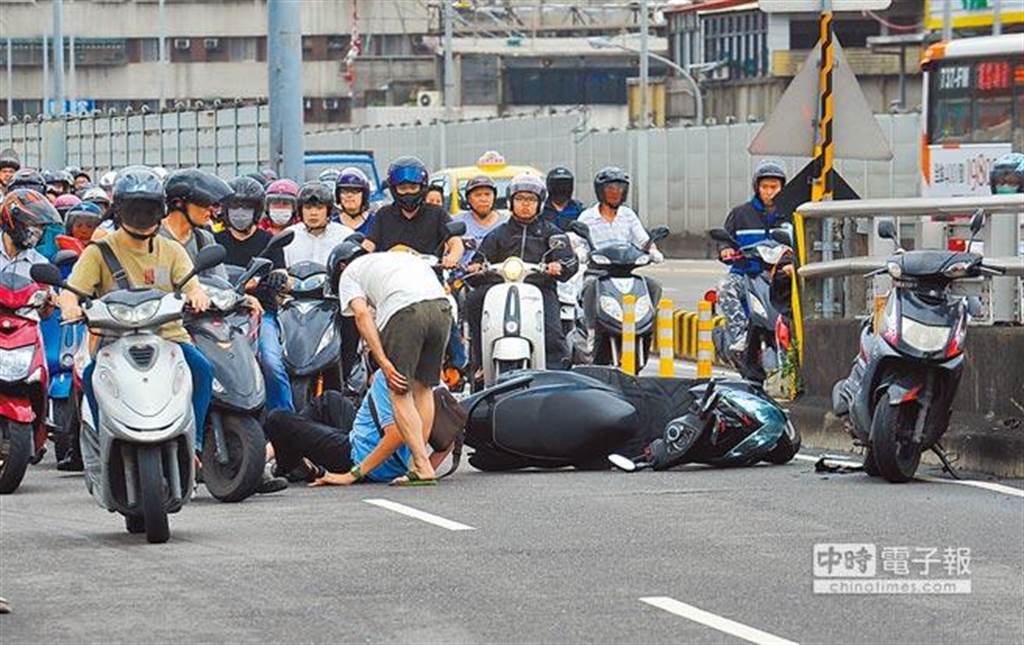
466,234,570,387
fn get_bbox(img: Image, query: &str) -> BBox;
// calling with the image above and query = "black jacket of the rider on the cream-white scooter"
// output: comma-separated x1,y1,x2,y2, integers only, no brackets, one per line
473,217,580,289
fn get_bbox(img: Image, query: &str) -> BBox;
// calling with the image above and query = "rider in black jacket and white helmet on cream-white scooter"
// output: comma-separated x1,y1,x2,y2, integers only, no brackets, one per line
466,174,579,370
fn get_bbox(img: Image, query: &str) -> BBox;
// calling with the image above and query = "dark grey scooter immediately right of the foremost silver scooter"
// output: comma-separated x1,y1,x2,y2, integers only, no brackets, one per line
185,249,280,502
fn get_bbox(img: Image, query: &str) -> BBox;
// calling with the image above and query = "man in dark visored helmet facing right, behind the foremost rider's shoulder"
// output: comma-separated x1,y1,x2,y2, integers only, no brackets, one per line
160,168,231,280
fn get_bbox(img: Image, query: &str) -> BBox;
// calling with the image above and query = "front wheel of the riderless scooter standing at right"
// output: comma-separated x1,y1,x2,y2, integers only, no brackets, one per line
870,394,921,483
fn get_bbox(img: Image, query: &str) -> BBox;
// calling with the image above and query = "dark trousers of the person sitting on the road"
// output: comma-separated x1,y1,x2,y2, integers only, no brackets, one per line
264,390,355,473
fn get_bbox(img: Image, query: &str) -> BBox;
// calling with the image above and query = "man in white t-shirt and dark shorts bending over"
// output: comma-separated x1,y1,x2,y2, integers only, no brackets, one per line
329,242,452,485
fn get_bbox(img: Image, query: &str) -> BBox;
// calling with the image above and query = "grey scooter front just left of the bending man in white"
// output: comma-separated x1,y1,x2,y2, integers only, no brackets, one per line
278,261,344,411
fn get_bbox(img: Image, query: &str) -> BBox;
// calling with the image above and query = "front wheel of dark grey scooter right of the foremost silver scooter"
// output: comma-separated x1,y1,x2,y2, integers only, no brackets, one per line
203,415,266,502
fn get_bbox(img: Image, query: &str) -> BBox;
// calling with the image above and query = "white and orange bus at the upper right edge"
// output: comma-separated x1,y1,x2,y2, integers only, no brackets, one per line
921,34,1024,197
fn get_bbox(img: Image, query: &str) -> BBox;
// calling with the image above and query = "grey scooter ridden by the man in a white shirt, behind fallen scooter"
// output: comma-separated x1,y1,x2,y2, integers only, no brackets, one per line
570,221,669,370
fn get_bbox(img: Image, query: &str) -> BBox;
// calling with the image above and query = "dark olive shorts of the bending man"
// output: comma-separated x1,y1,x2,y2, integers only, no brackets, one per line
381,299,452,387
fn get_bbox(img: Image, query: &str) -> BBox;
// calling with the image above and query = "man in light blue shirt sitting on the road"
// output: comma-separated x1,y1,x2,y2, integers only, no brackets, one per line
265,370,447,486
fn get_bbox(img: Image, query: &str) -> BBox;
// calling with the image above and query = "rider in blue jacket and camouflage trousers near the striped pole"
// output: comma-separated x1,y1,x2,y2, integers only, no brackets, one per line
718,160,793,353
